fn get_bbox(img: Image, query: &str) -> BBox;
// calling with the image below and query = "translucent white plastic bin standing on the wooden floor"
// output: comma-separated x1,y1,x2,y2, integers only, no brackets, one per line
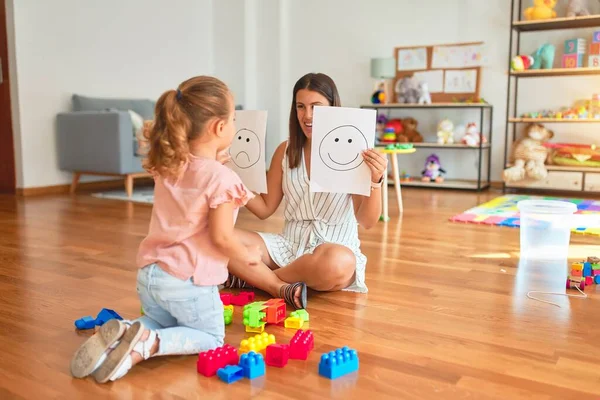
517,200,577,263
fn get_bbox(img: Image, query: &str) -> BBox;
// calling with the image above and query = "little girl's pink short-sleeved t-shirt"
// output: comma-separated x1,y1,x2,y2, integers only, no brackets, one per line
137,157,254,286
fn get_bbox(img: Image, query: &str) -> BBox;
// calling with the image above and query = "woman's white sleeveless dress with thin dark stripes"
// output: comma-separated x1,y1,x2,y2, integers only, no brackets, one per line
258,144,367,293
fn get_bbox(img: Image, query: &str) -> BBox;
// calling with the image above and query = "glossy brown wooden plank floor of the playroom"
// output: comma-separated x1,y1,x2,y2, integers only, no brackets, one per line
0,189,600,399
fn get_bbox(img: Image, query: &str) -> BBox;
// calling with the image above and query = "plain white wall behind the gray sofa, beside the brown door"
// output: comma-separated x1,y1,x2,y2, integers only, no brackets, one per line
14,0,214,187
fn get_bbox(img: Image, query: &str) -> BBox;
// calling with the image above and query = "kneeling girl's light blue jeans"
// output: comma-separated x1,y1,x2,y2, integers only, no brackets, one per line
132,264,225,356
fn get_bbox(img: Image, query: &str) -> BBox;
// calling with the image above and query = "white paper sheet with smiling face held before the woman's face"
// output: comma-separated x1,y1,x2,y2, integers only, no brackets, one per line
310,107,377,196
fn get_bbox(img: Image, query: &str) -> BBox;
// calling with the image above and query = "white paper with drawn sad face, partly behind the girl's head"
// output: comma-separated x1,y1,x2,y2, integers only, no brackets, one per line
227,110,267,193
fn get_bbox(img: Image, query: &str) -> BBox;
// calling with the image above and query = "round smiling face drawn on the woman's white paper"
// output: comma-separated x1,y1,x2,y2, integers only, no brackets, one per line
319,125,368,171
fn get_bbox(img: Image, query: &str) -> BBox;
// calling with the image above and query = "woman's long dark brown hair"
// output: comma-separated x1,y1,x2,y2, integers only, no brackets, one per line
287,73,342,168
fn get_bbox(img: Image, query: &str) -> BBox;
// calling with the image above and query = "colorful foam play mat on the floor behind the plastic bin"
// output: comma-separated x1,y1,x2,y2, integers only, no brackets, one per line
450,195,600,236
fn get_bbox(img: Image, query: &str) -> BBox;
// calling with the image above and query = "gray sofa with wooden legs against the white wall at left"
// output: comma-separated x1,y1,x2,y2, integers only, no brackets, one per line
56,95,155,197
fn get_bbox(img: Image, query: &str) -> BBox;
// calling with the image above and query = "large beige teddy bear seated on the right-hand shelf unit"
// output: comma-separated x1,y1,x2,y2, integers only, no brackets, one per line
503,124,554,182
